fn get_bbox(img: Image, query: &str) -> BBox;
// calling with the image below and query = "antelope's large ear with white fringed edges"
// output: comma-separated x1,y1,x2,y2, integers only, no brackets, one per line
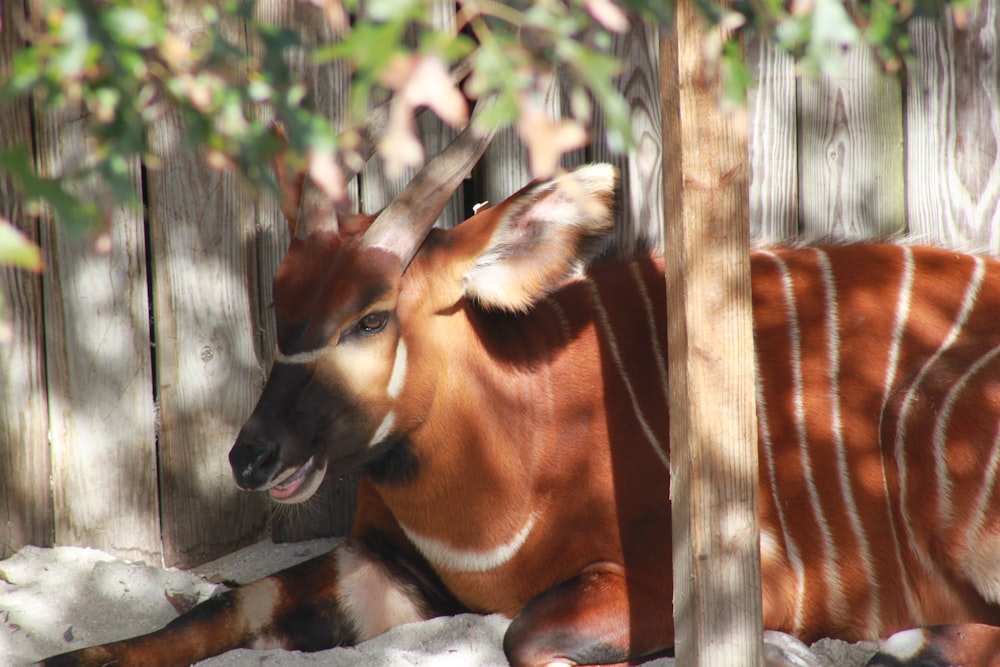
465,164,618,312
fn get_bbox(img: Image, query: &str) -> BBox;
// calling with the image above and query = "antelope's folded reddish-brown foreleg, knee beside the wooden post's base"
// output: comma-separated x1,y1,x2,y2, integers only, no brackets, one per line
504,570,673,667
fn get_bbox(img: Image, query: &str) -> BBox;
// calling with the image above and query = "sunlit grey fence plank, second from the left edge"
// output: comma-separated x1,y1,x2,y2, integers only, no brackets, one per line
35,109,161,562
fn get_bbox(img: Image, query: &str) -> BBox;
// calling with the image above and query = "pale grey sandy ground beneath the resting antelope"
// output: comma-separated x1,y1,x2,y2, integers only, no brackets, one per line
0,540,872,667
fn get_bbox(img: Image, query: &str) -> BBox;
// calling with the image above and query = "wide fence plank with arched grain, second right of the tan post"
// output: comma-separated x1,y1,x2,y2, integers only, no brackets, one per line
799,46,905,240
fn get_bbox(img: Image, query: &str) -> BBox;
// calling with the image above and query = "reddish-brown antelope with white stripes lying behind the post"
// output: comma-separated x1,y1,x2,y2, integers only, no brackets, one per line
44,117,1000,667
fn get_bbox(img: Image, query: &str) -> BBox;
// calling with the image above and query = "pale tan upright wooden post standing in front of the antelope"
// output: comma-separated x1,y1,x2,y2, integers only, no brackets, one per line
661,0,763,666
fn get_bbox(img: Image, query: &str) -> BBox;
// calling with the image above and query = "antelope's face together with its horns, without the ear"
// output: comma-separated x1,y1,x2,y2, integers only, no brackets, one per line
229,123,492,502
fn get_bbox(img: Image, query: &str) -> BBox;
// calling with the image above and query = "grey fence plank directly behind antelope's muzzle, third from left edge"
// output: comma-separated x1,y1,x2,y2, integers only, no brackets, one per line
147,5,269,566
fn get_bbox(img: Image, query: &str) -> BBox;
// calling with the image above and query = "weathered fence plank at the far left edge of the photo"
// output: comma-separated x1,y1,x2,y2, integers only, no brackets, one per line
0,2,55,560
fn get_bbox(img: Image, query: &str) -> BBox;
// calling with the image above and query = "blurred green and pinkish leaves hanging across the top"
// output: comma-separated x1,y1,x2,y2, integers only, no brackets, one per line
0,0,974,269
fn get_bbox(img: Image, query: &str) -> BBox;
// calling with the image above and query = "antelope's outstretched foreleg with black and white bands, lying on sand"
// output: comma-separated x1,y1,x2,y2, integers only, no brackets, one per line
40,540,440,667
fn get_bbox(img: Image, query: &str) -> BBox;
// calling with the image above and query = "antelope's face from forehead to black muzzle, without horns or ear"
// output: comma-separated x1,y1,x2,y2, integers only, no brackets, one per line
229,234,406,503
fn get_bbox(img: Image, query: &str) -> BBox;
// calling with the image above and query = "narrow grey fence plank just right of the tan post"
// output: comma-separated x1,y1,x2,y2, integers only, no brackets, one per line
746,33,799,240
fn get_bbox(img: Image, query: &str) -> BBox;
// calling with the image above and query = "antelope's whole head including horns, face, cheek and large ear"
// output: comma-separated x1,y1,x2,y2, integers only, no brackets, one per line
229,118,617,502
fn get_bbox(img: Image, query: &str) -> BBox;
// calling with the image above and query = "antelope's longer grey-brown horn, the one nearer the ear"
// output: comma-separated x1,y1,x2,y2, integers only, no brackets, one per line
361,101,496,271
